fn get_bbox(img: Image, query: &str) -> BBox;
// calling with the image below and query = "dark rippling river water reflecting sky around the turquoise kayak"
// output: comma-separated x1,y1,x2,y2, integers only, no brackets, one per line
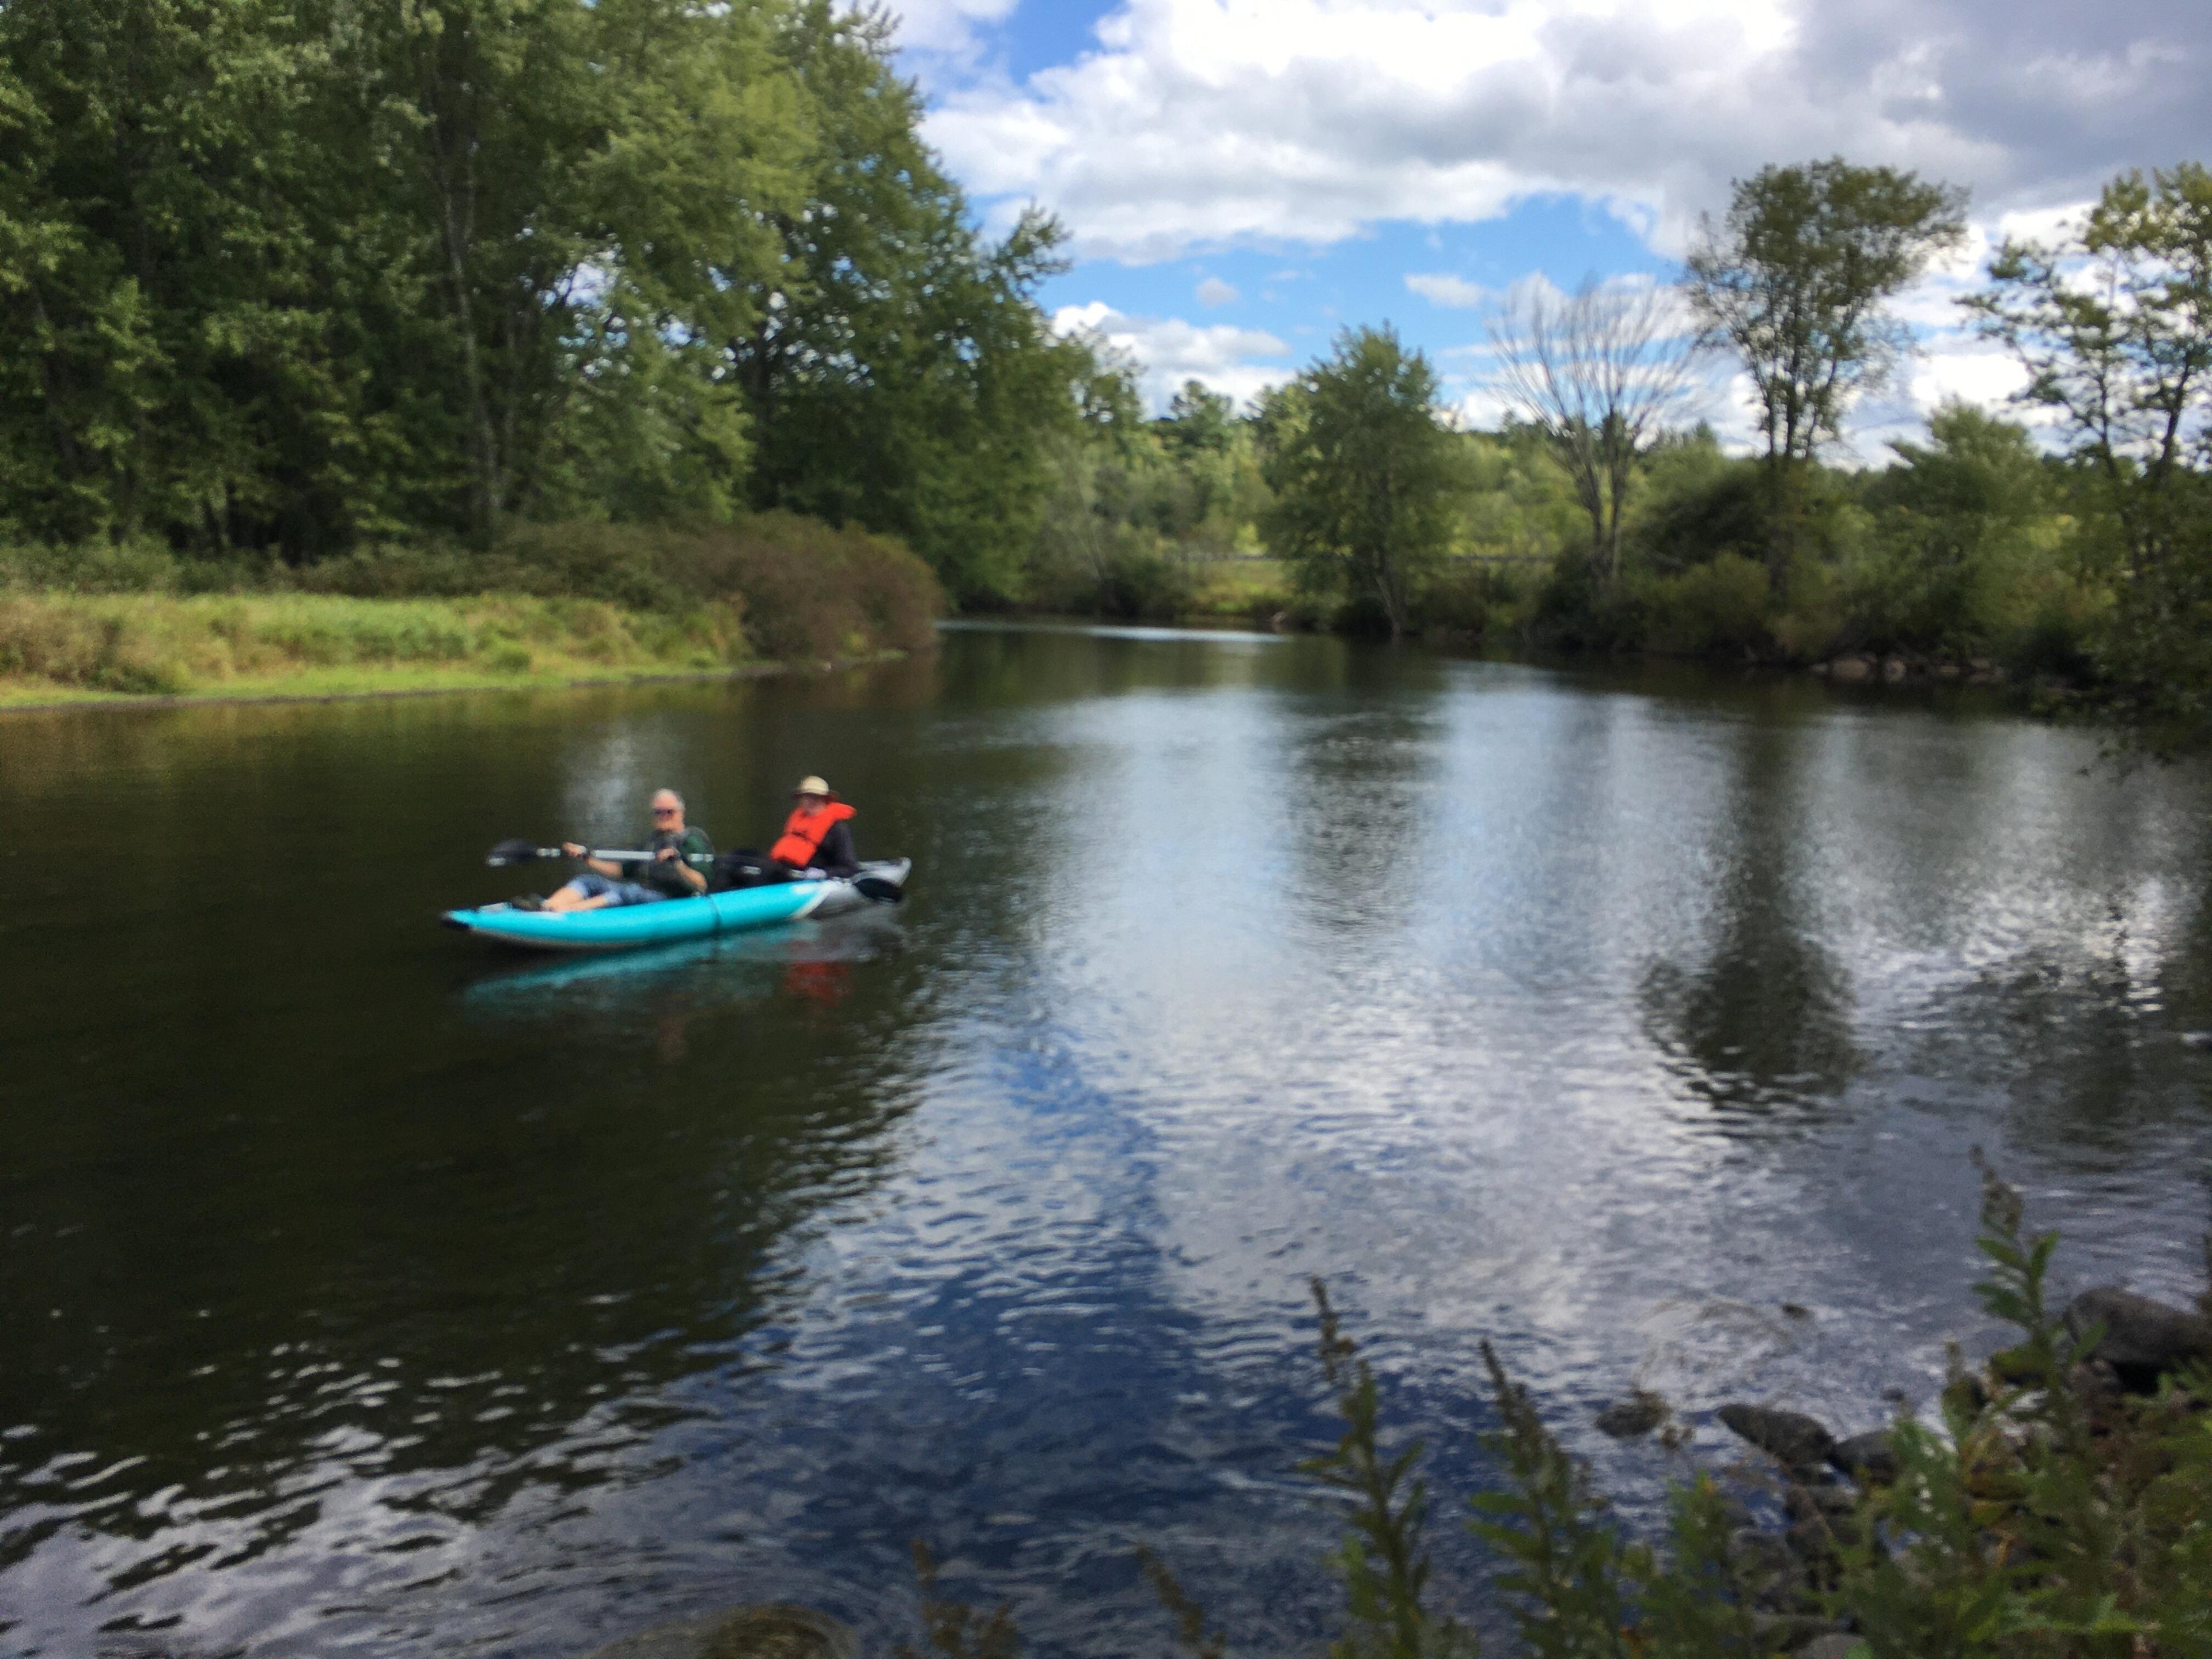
0,628,2212,1659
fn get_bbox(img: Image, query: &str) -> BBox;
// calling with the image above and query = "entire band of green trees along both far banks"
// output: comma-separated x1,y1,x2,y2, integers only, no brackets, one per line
0,0,2212,737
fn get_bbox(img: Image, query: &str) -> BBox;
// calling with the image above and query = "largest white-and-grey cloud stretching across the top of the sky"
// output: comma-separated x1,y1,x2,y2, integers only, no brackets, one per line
929,0,2212,261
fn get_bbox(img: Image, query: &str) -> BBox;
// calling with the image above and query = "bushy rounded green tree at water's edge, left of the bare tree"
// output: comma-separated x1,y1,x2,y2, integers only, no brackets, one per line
1261,327,1467,639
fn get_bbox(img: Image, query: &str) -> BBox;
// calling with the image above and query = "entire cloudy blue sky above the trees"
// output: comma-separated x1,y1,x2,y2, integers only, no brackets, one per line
893,0,2212,460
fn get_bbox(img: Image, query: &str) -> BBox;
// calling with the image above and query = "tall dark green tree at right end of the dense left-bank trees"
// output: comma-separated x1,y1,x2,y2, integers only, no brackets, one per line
730,0,1097,601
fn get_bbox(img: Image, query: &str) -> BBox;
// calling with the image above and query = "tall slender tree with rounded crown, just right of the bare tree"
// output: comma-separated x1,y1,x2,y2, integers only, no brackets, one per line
1688,157,1967,597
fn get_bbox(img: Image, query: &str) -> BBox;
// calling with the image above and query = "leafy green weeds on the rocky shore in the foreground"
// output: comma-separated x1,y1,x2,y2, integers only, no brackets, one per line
902,1168,2212,1659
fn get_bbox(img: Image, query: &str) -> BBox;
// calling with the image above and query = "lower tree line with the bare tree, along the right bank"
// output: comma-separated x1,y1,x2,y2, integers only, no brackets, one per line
1042,159,2212,737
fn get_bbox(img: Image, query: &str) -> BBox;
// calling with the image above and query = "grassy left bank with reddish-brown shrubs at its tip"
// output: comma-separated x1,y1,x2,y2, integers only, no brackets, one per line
0,516,942,706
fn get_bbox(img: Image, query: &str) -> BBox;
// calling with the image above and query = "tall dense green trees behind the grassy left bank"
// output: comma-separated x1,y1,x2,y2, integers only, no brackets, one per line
0,0,1115,595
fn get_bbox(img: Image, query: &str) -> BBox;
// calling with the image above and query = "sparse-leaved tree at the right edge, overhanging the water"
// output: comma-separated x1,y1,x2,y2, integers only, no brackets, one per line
1969,161,2212,741
